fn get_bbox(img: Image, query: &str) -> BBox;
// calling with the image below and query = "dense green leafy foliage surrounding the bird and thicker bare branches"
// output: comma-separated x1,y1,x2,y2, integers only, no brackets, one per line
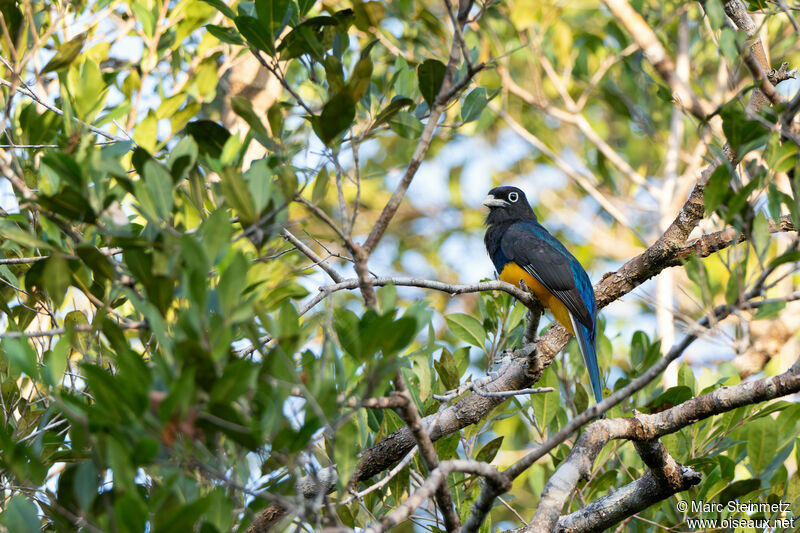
0,0,800,533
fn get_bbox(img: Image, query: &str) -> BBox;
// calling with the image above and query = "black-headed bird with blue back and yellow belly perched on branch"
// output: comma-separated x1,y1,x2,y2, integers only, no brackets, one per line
483,187,603,402
